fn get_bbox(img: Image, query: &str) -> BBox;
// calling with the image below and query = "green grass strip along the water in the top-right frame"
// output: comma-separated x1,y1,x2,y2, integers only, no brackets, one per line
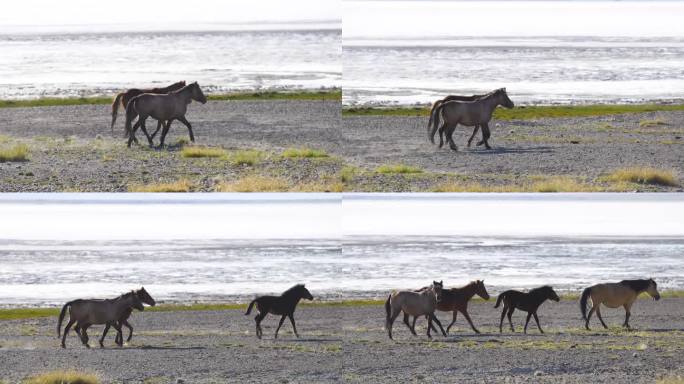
342,104,684,120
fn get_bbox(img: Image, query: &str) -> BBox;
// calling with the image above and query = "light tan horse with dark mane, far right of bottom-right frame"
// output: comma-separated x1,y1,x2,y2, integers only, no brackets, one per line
580,279,660,329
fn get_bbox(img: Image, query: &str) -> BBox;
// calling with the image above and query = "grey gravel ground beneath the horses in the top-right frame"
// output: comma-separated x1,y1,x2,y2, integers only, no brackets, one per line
341,112,684,191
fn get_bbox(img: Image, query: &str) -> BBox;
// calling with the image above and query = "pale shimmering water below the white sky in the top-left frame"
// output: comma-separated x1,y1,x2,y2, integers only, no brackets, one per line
0,26,342,99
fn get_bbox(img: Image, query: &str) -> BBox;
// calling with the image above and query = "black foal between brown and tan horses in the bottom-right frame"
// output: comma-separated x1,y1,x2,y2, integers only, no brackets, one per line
494,285,560,333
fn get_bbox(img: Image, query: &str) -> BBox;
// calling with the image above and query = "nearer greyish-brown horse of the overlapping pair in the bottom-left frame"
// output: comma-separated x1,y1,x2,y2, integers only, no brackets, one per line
57,291,145,348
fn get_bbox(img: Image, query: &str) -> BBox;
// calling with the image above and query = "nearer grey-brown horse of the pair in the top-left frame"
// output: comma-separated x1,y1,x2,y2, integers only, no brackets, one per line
126,82,207,148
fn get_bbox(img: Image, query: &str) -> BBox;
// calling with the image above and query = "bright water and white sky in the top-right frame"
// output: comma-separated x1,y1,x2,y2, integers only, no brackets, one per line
343,1,684,105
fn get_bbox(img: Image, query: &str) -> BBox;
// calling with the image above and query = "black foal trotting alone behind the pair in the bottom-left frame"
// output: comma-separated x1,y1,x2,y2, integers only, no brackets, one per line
245,284,313,339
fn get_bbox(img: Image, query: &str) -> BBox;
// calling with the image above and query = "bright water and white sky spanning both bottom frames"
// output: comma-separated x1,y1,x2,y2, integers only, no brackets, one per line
0,194,684,306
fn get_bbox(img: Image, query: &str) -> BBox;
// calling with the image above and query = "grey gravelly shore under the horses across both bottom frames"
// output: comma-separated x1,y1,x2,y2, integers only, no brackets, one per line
0,299,684,383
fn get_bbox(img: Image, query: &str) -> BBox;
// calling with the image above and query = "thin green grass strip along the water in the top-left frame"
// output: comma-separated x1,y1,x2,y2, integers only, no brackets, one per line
0,89,342,108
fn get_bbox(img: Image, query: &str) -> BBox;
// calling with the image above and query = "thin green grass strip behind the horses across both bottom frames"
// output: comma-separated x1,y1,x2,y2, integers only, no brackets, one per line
5,290,684,321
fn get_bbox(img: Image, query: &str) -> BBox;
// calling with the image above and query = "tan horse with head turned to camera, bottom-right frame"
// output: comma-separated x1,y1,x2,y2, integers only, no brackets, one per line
385,281,446,339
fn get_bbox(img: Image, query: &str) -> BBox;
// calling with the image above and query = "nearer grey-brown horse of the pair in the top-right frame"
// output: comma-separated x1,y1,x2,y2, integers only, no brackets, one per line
433,88,515,151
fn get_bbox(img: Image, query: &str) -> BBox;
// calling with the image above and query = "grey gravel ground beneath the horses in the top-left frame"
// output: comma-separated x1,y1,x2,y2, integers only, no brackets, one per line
0,101,341,192
